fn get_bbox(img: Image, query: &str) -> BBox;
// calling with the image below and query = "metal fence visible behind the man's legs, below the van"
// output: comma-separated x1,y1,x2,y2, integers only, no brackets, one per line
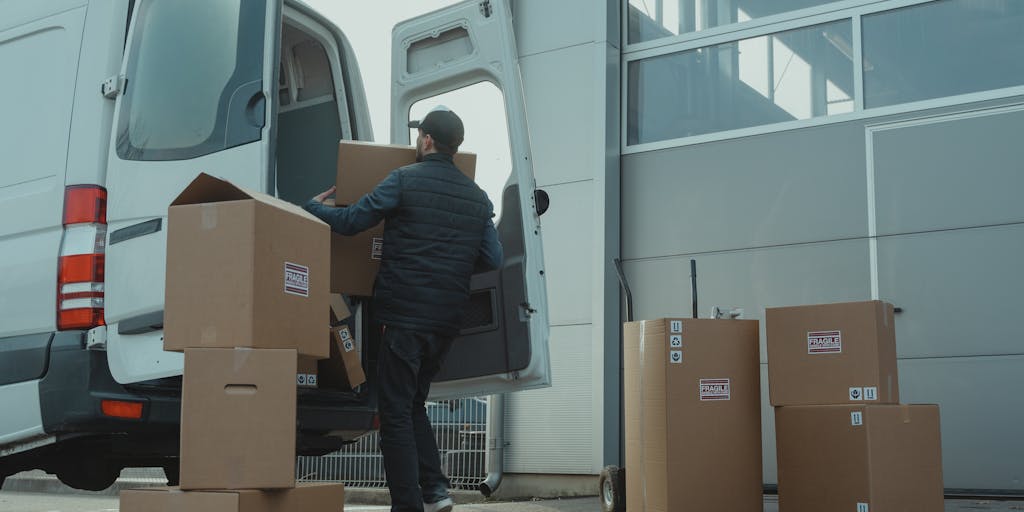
296,398,487,490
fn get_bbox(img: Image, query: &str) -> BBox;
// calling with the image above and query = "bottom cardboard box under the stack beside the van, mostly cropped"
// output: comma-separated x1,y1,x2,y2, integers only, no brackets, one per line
121,483,345,512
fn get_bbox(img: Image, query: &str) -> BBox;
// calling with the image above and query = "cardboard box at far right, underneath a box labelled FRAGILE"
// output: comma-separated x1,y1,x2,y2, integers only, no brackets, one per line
775,406,943,512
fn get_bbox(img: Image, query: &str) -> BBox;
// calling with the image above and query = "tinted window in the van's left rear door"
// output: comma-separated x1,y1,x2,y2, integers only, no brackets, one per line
117,0,265,160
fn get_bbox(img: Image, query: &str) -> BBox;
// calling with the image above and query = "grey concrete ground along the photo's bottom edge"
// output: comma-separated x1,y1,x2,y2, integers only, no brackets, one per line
0,490,1024,512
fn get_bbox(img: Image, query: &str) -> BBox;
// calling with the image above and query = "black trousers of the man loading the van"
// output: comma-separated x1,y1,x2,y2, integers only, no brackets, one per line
377,327,453,512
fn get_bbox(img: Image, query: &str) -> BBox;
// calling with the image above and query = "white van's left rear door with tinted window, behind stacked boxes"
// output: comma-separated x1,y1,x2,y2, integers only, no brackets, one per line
104,0,282,383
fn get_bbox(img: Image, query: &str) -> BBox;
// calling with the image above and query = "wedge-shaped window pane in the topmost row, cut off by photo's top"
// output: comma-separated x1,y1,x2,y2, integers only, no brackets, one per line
628,0,839,43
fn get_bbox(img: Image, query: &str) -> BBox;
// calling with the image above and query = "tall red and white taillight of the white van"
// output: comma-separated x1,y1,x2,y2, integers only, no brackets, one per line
56,185,106,331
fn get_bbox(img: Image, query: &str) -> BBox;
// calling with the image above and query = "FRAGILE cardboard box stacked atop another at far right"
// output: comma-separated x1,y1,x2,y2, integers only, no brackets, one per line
765,300,899,406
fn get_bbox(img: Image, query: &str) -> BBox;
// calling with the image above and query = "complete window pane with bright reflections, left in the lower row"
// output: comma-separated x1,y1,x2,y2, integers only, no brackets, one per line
627,19,853,144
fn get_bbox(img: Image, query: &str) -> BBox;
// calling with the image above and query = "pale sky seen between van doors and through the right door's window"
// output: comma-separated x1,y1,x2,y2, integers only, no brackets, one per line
304,0,511,215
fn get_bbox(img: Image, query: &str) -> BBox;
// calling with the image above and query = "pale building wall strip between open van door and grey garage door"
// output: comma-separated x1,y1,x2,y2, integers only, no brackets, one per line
505,0,621,475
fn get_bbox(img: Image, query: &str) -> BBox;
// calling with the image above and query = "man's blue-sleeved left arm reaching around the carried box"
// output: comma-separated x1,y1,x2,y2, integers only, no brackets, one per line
303,172,401,236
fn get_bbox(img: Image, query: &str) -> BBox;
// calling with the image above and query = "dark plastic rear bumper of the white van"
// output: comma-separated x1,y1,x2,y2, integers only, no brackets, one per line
39,332,376,457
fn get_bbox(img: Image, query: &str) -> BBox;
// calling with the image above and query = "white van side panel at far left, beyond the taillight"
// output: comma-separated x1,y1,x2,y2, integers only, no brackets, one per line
0,4,87,338
